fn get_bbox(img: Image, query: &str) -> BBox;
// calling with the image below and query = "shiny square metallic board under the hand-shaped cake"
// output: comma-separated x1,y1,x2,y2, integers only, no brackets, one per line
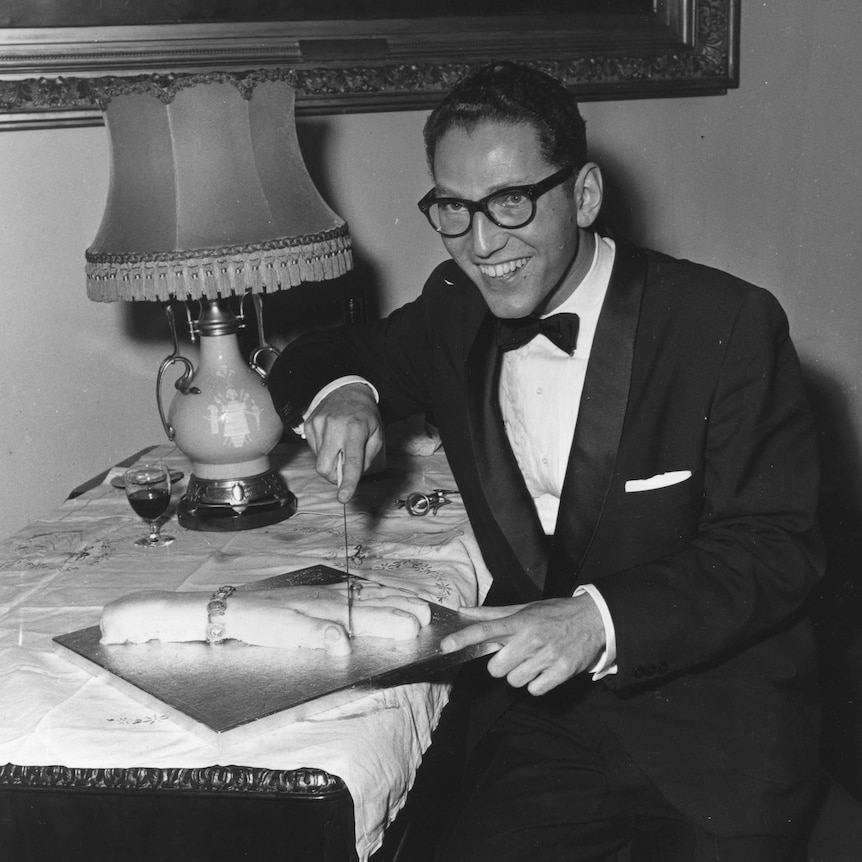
54,565,488,744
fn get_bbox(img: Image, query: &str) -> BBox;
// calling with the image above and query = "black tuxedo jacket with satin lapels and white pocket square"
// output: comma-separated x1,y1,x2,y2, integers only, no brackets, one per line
270,236,823,834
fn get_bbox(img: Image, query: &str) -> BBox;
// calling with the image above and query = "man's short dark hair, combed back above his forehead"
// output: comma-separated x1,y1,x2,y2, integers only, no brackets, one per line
423,61,587,172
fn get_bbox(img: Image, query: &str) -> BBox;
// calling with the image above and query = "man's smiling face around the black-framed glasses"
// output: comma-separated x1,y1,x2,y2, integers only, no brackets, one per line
434,121,583,318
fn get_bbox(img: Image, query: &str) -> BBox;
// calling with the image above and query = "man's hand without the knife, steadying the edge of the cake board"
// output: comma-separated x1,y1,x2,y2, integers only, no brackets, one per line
440,595,605,695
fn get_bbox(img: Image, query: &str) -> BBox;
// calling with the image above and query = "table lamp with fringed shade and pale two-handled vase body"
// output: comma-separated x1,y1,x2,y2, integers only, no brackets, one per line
86,75,352,531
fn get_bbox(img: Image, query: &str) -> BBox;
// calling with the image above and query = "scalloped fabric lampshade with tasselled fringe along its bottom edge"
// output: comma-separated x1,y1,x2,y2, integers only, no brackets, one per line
87,76,352,302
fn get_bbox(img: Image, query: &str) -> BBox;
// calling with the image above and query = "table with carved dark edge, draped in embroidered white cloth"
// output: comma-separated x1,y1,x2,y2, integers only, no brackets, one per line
0,444,490,862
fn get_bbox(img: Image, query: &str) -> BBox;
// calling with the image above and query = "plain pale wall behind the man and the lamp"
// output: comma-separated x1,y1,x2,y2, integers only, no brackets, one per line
0,0,862,536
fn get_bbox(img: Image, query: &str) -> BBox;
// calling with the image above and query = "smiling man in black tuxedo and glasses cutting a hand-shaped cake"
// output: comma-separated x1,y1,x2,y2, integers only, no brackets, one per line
270,63,823,862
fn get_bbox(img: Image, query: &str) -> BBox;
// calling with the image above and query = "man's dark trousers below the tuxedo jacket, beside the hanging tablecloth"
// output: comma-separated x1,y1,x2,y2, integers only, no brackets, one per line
435,699,804,862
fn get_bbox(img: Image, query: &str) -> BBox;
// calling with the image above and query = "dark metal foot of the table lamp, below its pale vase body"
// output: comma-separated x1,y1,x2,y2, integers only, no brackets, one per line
177,470,296,532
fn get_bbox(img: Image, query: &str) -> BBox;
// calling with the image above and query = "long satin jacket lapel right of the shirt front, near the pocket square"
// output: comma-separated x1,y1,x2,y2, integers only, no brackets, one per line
545,241,646,597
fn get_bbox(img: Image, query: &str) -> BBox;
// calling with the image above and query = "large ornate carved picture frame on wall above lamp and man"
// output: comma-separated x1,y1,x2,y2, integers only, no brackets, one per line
0,0,740,130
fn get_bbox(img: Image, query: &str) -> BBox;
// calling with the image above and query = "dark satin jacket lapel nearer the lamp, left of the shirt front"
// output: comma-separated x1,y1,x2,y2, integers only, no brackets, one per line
467,314,548,600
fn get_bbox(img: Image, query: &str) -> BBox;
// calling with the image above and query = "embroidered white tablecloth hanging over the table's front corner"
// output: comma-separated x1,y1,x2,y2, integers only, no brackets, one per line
0,445,490,860
